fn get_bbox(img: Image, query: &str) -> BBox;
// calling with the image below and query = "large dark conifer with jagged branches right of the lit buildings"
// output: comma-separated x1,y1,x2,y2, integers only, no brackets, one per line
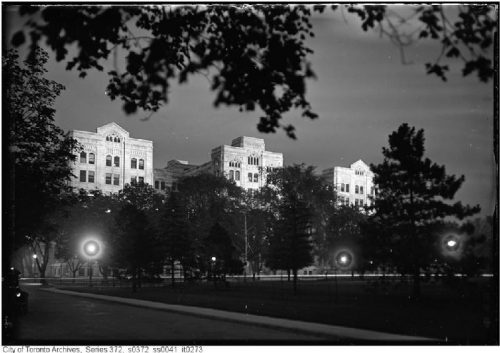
369,123,479,298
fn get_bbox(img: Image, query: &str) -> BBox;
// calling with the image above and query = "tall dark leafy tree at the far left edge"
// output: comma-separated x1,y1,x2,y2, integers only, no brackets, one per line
2,49,77,268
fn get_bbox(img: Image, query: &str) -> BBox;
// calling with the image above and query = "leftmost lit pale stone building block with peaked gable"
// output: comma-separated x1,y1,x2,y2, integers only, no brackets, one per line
71,123,153,193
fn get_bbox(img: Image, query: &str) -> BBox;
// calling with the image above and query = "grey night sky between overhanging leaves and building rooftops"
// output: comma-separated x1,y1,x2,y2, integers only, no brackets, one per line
4,7,496,215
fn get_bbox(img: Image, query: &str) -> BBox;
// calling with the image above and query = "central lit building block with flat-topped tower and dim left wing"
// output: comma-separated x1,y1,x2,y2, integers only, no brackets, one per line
155,136,283,191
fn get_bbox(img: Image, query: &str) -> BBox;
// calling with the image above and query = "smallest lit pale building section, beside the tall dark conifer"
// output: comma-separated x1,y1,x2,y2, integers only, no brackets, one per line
322,160,375,206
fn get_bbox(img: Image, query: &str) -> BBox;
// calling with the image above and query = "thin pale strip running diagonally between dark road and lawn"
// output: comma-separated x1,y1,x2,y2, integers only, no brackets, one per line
43,288,438,344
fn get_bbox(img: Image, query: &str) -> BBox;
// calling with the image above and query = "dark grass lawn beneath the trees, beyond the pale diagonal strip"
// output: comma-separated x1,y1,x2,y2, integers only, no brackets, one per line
55,279,498,344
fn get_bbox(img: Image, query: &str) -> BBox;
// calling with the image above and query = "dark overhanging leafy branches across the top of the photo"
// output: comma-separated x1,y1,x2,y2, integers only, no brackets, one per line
12,4,497,138
